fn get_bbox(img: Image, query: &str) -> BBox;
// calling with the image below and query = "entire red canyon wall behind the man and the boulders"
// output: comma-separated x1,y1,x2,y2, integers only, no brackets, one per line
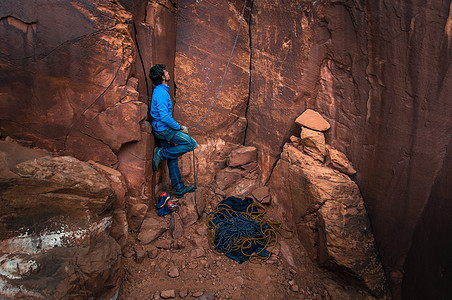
0,0,452,299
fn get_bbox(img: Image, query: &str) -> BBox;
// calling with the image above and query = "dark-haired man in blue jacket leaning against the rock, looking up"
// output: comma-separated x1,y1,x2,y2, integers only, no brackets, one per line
149,64,197,198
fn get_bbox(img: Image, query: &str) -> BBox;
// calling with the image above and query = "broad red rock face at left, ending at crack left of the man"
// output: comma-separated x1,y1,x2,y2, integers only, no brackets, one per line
0,0,138,165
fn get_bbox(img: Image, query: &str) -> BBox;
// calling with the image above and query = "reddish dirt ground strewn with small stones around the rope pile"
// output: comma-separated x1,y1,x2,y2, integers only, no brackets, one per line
118,189,367,300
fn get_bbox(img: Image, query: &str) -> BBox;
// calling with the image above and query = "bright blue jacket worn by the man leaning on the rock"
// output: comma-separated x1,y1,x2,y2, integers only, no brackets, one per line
151,84,180,131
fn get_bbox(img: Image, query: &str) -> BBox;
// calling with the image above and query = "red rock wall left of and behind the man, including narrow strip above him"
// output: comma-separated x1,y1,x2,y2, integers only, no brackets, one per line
0,0,177,196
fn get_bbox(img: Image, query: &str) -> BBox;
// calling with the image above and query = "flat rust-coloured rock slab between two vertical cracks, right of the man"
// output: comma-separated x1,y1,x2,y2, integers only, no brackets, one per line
174,0,250,143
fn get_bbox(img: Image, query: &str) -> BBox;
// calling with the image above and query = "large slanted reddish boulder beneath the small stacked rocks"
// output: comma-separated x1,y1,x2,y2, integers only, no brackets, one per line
269,144,388,298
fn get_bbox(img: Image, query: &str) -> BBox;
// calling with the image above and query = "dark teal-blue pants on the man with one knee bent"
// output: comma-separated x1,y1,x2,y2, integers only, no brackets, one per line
154,128,198,192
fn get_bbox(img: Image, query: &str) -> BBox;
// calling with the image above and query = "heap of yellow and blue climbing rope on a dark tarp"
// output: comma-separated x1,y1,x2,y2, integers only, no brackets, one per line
207,198,294,263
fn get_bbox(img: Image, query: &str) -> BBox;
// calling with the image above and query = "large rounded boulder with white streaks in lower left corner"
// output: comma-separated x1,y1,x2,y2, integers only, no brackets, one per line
0,143,122,299
